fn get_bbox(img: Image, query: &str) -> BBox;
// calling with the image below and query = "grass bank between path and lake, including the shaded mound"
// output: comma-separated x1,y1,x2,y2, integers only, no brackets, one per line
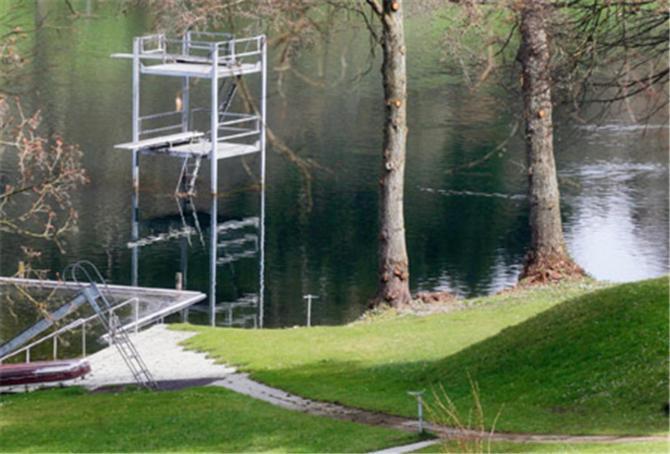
181,278,668,434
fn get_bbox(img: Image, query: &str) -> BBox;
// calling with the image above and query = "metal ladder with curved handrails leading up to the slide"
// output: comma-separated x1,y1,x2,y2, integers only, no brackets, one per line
63,260,158,390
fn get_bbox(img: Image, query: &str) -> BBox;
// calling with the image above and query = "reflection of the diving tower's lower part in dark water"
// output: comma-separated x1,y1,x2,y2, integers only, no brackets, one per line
127,193,265,328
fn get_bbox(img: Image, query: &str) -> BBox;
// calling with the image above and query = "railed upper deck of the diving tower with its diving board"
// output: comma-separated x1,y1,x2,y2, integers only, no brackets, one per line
112,32,265,79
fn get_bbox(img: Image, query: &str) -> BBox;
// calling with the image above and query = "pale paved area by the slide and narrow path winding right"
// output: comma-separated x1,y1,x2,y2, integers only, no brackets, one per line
69,325,668,453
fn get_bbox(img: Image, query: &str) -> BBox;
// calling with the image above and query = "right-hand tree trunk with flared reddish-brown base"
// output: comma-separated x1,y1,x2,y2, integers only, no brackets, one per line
517,0,583,282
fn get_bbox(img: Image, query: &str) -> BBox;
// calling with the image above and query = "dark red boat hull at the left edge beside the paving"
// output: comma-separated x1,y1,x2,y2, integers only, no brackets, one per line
0,359,91,386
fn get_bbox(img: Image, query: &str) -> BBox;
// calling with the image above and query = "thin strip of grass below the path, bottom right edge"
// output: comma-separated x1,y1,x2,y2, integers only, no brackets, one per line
416,441,670,454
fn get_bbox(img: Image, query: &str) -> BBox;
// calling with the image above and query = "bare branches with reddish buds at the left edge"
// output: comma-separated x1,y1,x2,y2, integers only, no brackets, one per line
0,24,88,251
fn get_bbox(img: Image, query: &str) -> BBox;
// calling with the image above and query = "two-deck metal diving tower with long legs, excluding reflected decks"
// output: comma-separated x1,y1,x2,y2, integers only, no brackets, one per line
112,31,267,325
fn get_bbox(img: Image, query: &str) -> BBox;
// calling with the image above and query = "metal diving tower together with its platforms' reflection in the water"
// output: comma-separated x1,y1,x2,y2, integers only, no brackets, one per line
116,31,267,326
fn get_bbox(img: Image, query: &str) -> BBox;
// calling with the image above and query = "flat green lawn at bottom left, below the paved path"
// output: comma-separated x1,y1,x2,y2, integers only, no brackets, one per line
0,387,417,452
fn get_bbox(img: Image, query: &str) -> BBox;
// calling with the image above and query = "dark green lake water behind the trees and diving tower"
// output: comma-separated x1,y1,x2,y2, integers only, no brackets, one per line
0,1,669,327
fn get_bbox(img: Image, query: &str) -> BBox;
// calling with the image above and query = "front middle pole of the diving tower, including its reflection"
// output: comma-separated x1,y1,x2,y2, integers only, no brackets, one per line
209,43,219,326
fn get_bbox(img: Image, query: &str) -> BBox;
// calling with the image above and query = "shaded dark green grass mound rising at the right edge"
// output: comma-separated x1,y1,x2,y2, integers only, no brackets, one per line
427,278,668,434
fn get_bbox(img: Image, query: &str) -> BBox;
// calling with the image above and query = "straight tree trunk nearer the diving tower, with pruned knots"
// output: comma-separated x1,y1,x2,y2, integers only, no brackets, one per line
373,0,411,306
